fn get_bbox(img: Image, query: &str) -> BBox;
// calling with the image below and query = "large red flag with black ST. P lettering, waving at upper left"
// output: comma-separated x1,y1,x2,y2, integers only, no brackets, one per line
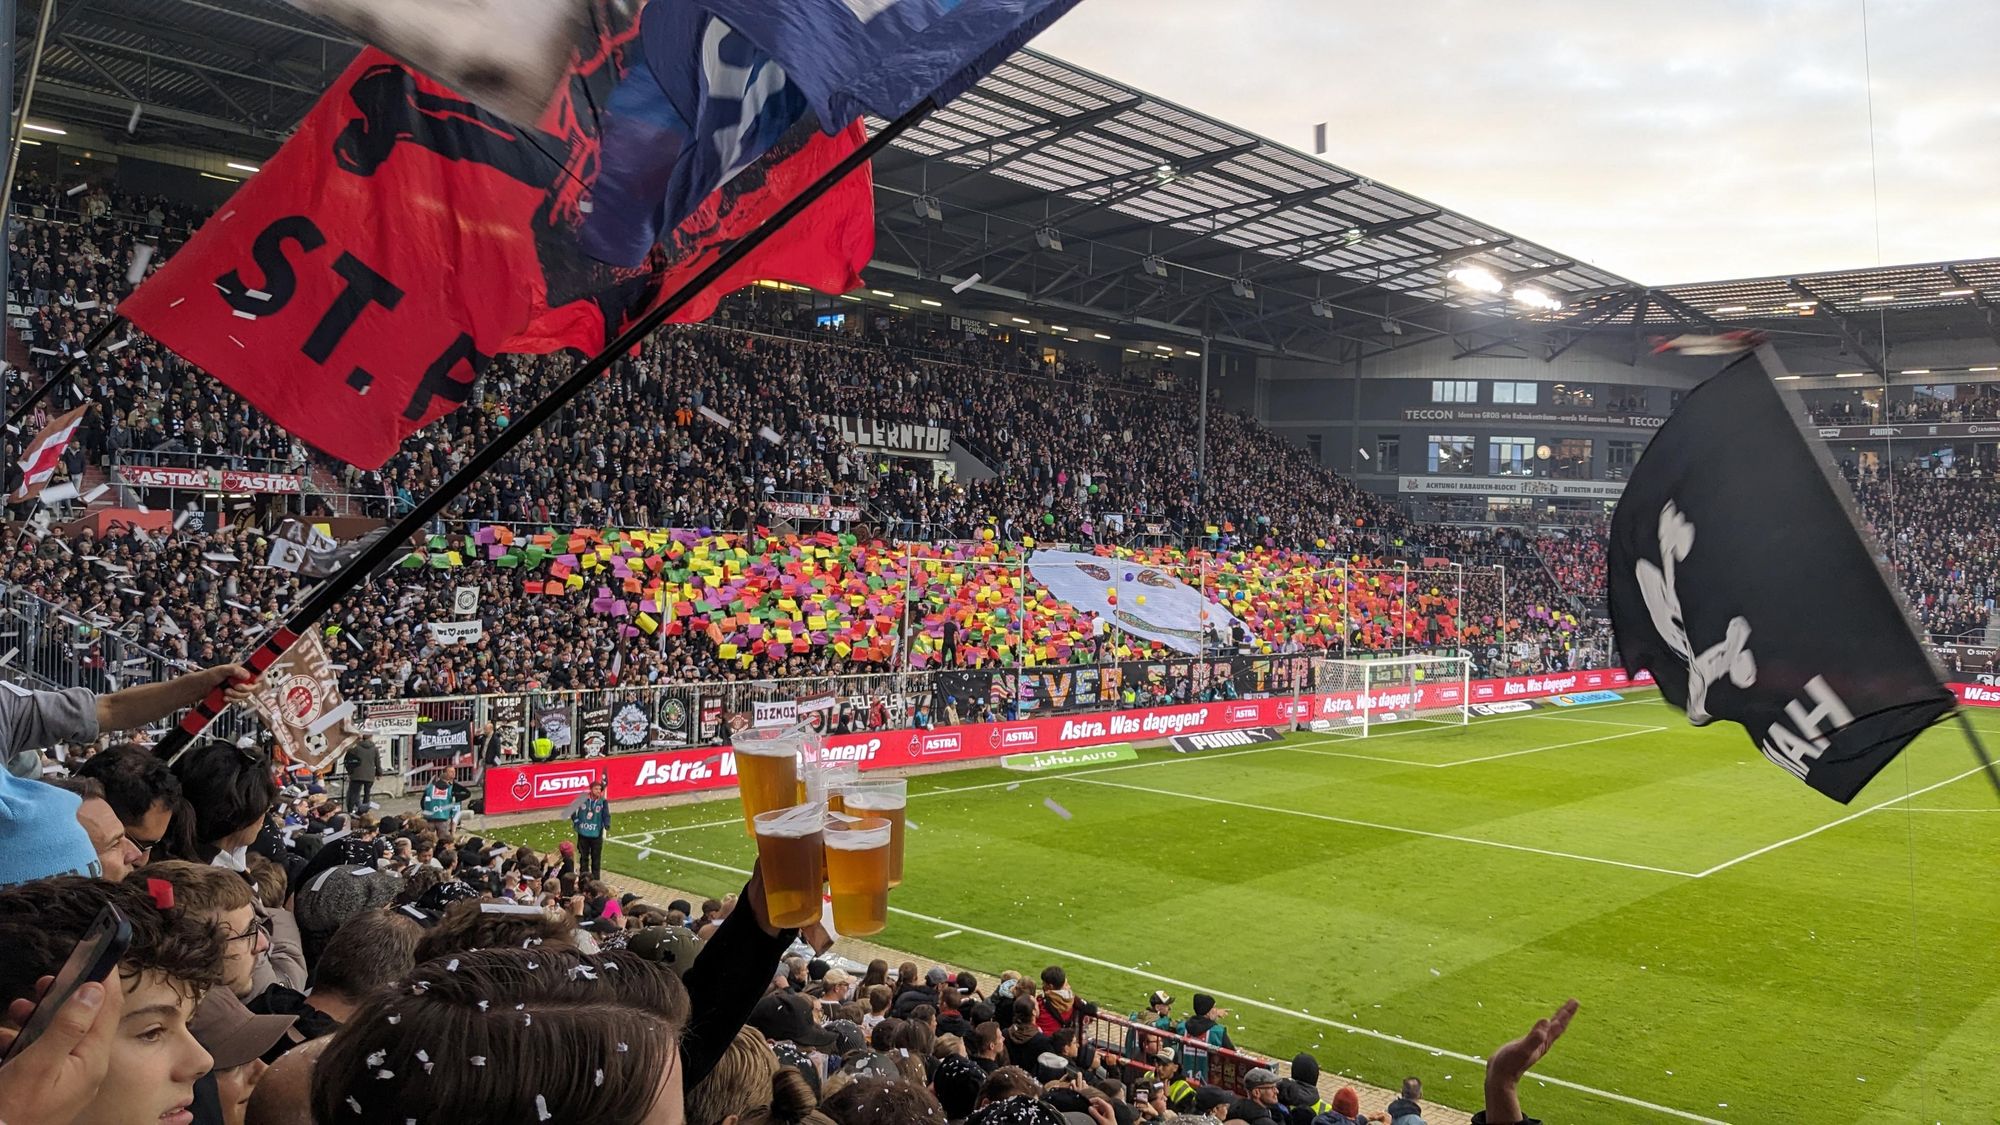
118,16,874,468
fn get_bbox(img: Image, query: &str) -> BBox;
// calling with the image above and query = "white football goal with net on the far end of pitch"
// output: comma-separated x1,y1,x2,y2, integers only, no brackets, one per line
1300,655,1472,739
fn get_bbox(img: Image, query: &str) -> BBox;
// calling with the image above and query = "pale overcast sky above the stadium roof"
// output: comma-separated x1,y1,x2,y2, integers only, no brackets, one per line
1034,0,2000,284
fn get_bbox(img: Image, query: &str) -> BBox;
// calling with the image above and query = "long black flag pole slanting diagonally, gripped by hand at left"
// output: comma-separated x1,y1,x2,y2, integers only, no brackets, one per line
154,98,936,759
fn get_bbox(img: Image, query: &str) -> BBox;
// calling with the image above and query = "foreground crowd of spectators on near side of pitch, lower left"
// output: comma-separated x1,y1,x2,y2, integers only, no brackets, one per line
0,667,1576,1125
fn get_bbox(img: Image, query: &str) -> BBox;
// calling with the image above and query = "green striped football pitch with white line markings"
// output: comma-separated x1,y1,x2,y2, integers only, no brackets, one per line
506,697,2000,1125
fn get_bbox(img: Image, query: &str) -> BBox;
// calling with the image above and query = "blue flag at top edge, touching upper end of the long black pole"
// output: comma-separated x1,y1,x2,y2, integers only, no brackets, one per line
698,0,1078,128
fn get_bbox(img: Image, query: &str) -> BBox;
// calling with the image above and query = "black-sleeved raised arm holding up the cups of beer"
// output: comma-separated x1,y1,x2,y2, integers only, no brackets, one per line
680,865,798,1089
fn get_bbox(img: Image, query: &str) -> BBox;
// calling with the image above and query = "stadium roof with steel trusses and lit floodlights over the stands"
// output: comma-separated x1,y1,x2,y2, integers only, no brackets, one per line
27,0,2000,358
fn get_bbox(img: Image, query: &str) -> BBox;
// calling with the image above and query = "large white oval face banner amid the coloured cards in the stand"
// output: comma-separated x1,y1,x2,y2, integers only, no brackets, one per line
1028,550,1248,655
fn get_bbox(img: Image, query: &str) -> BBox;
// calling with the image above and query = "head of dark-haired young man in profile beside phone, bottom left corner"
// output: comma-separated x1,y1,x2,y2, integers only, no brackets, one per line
0,877,222,1125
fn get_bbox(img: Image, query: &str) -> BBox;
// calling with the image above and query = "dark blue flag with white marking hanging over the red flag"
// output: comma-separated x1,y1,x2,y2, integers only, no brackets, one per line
582,0,804,266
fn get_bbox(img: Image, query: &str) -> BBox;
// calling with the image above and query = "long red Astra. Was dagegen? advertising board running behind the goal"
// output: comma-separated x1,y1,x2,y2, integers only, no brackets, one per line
486,671,1656,815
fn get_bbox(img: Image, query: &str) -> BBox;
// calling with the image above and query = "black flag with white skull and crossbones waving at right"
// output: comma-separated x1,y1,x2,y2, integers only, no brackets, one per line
1610,356,1954,803
